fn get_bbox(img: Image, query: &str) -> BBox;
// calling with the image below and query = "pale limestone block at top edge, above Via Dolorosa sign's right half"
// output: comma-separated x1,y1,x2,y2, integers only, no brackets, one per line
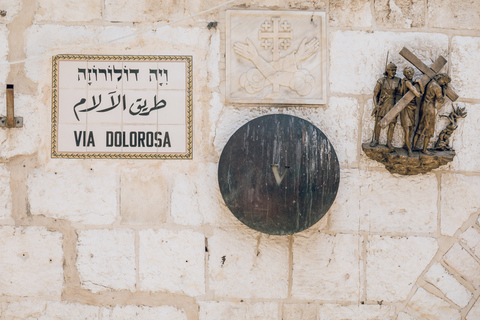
105,0,188,22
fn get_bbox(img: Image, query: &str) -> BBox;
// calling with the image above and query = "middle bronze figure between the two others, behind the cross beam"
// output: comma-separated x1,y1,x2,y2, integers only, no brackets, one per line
400,67,423,157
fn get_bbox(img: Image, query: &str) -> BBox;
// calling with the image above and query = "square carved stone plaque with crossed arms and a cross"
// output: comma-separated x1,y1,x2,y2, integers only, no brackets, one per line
226,10,327,104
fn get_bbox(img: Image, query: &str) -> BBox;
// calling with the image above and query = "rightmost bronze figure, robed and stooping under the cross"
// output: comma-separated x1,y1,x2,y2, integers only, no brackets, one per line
413,73,452,154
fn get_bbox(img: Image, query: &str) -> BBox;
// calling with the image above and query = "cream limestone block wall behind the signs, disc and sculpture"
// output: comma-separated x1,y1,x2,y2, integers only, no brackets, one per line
0,0,480,320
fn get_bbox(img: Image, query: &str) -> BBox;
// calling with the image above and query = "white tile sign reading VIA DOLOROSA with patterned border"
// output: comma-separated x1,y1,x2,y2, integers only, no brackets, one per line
52,55,193,159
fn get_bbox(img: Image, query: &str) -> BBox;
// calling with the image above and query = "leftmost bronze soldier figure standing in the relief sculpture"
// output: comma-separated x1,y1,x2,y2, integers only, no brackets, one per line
370,62,401,149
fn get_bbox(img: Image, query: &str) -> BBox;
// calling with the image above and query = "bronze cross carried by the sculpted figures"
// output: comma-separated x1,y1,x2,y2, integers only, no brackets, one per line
379,47,458,128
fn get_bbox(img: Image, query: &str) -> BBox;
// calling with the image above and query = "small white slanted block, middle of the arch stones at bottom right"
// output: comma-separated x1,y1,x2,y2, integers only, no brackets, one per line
425,263,472,308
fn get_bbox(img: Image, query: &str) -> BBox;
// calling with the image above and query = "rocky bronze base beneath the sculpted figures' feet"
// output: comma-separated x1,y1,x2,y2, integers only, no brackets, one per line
362,143,455,175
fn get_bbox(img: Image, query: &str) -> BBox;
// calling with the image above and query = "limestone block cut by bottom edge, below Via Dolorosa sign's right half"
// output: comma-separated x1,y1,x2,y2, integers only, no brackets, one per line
102,305,187,320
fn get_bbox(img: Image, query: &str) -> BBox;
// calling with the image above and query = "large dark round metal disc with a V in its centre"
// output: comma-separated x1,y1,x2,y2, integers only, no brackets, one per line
218,114,340,235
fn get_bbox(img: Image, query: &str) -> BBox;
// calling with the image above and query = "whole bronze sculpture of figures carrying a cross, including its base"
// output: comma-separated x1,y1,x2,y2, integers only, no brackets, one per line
362,48,467,175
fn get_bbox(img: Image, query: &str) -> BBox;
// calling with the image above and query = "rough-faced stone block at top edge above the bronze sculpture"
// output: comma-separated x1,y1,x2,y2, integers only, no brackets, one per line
374,0,425,28
